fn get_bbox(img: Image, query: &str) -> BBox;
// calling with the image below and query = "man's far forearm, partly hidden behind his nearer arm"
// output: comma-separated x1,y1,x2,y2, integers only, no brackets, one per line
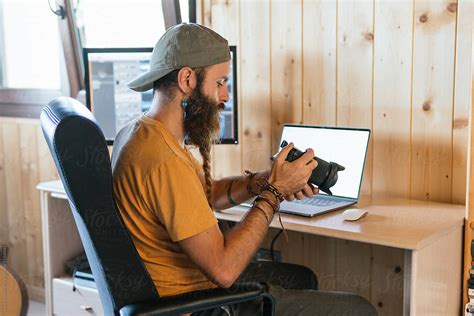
212,171,269,210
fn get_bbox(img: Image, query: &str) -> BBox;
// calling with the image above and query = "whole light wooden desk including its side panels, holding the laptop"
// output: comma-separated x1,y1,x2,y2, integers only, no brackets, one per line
37,181,465,316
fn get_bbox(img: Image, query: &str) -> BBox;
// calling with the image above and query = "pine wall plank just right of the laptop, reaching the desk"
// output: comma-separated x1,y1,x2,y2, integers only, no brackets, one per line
372,0,413,198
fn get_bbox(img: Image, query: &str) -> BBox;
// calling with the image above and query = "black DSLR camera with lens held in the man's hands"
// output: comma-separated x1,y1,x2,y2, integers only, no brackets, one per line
280,140,346,195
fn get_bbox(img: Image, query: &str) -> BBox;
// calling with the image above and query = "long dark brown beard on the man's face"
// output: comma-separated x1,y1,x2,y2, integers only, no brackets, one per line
184,84,224,150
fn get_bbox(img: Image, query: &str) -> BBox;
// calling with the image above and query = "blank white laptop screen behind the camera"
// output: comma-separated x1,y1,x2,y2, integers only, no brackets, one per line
280,125,370,199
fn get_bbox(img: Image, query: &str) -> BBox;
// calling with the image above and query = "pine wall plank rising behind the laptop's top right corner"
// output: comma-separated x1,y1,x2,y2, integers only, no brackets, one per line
336,0,374,195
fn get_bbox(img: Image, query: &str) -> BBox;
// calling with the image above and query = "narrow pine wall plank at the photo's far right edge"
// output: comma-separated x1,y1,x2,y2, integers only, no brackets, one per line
452,0,473,204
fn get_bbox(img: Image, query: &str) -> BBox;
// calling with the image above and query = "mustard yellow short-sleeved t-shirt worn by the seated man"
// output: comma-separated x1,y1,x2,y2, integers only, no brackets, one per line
112,115,217,296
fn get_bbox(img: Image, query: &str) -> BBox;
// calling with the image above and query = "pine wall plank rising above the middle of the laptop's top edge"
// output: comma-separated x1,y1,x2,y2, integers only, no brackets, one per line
302,0,337,126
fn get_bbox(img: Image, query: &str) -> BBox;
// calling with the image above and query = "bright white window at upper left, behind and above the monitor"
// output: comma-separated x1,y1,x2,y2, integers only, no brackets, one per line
0,0,196,118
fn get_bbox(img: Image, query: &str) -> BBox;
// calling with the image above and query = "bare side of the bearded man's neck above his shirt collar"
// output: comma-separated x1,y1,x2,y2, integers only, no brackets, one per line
146,93,185,146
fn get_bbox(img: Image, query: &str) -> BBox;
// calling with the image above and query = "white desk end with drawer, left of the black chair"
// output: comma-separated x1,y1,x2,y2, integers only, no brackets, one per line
38,181,104,316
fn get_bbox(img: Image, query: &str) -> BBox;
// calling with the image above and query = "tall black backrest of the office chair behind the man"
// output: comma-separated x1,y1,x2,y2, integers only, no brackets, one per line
41,97,159,315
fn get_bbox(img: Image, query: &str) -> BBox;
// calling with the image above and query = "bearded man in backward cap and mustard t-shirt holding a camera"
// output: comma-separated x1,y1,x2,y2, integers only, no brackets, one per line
112,24,376,315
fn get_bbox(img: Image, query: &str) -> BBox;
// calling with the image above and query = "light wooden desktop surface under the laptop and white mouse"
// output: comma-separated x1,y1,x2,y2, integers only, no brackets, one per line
221,199,465,250
